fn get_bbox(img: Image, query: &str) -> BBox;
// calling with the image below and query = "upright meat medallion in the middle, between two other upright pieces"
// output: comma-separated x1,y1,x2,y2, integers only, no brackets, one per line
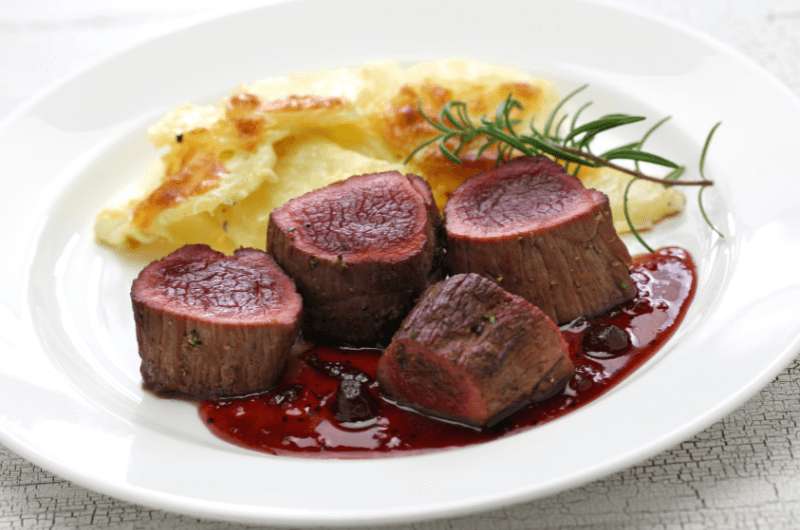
267,171,441,346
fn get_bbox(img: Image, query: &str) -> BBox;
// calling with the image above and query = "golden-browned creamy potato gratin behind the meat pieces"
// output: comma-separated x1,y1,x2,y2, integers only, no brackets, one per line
95,60,684,252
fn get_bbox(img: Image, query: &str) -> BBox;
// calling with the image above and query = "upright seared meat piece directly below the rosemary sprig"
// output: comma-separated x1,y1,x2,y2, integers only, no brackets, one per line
445,156,636,324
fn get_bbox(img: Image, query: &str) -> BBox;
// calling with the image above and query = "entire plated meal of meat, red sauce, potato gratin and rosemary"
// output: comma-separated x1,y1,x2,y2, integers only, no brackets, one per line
114,56,724,456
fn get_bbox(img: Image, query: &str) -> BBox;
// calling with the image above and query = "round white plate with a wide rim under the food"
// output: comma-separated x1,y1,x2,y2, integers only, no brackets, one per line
0,0,800,525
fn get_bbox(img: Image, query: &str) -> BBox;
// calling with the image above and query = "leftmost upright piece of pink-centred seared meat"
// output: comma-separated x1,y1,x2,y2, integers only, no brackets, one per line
131,245,303,399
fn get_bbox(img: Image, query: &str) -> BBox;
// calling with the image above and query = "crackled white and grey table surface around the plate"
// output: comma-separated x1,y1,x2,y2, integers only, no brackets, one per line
0,0,800,530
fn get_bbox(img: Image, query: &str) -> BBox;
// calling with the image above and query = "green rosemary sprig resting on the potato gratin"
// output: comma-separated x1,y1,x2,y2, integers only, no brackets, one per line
404,85,722,248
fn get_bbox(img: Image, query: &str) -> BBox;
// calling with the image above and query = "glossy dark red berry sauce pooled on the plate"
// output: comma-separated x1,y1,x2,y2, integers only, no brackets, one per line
200,247,695,458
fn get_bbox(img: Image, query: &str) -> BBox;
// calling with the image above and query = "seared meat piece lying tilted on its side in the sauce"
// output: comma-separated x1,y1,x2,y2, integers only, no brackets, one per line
378,274,573,427
